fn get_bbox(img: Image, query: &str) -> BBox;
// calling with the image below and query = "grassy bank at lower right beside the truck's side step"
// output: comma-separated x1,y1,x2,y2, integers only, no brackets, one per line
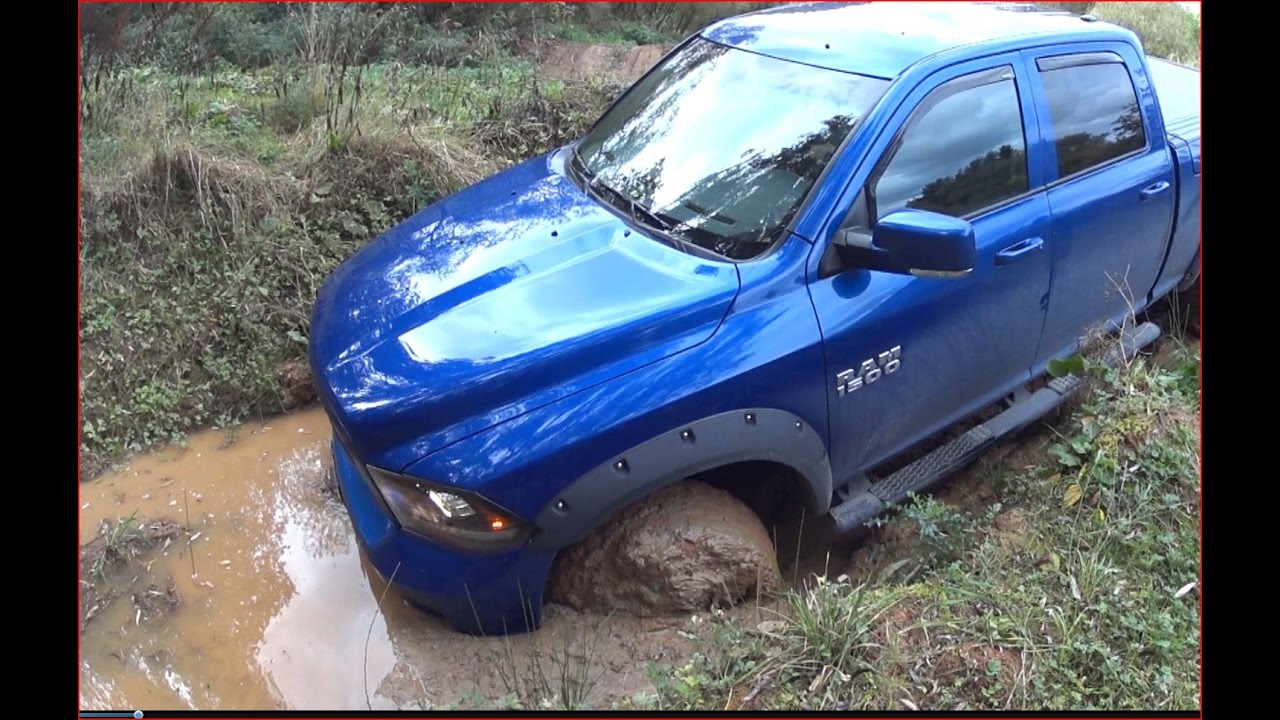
645,338,1199,711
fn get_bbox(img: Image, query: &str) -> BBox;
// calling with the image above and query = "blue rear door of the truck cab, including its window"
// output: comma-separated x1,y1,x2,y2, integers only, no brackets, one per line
1024,44,1176,363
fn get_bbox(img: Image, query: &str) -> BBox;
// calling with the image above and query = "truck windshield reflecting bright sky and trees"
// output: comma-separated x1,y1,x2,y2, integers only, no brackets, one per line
575,38,888,260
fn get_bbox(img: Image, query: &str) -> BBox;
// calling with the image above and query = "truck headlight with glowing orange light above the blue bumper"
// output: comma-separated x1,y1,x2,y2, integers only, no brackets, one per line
369,468,529,551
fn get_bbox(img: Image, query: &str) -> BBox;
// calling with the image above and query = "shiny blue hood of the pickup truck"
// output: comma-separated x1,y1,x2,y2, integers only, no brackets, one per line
310,148,739,469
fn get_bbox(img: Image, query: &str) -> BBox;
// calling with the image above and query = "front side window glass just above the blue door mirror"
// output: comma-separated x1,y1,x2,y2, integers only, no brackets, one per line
872,67,1029,218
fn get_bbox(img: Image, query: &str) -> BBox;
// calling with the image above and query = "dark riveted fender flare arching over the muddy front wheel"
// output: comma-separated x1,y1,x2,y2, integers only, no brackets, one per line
529,407,832,550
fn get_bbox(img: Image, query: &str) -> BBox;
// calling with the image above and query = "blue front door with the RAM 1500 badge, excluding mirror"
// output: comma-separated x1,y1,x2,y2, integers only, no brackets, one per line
810,54,1050,480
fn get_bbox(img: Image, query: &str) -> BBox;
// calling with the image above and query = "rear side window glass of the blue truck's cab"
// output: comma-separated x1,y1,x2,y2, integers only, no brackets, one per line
1041,63,1147,178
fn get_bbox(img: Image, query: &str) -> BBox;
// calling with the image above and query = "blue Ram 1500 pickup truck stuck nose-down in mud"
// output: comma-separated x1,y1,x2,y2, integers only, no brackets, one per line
310,3,1201,633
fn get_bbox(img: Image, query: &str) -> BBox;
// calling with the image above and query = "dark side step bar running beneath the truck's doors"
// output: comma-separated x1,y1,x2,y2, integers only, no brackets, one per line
831,323,1160,533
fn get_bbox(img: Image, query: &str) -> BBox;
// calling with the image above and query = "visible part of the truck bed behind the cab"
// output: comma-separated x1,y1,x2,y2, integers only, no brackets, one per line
1147,58,1201,292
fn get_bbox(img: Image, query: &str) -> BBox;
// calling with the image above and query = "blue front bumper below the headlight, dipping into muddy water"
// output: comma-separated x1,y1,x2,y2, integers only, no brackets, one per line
333,437,556,635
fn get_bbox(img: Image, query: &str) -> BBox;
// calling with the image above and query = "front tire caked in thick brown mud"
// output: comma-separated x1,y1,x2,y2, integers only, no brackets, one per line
547,480,780,616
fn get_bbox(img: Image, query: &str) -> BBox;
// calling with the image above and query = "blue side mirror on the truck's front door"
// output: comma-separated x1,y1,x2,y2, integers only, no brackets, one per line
836,210,978,278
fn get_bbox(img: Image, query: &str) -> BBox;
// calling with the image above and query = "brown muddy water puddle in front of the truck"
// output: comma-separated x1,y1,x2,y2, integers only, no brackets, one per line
81,410,721,710
